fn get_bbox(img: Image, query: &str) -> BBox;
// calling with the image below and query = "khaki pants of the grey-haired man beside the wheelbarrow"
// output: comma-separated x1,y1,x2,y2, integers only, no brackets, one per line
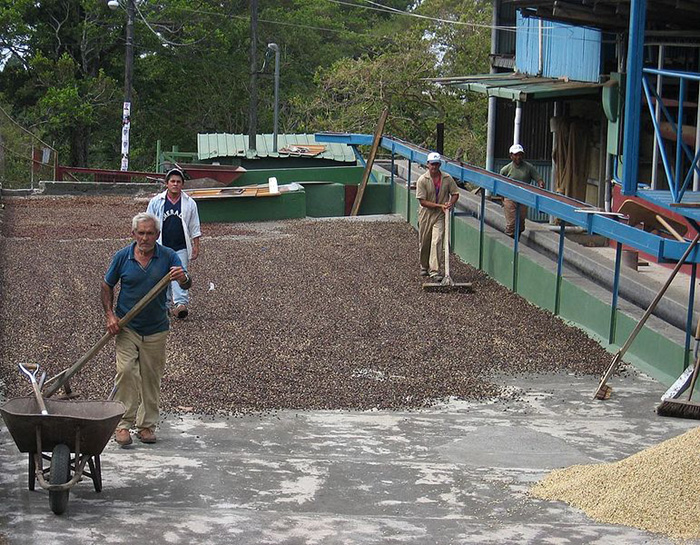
114,328,168,430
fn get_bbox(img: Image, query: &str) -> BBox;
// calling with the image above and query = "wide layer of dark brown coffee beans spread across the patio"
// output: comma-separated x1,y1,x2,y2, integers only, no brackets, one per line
0,196,610,414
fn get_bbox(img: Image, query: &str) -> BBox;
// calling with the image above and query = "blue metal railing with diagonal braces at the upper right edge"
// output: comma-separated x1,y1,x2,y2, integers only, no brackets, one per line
642,68,700,203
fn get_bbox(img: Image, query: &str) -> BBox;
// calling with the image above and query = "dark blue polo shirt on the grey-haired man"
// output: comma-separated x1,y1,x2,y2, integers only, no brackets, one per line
104,242,182,335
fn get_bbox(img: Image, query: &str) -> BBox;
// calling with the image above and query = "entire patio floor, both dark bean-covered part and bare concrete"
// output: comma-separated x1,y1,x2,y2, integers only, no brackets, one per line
0,198,697,545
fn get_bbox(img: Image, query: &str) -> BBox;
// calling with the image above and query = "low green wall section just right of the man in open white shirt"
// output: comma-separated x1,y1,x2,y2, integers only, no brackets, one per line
197,190,306,223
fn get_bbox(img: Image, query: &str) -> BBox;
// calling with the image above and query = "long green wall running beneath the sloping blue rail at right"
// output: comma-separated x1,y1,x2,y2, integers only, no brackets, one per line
393,185,688,382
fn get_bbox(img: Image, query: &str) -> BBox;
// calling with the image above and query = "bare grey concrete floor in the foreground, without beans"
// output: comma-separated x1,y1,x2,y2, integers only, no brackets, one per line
0,373,697,545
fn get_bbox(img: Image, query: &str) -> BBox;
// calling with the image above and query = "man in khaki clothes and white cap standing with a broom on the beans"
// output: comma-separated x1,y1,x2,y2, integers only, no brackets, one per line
416,152,459,282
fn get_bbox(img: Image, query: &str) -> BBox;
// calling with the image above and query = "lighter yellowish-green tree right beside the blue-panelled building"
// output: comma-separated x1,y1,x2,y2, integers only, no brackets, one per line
284,0,490,162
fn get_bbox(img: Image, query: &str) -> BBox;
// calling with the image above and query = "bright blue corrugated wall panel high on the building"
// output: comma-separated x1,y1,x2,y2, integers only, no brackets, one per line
515,11,601,82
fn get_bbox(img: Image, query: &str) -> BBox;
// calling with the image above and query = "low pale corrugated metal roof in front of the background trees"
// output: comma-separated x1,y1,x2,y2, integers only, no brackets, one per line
197,133,357,164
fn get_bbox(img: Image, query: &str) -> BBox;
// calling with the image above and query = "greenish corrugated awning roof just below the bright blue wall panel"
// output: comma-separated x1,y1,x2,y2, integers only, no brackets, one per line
432,73,602,102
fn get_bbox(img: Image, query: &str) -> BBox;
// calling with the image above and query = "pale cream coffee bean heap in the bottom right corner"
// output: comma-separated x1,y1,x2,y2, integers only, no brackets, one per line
530,428,700,540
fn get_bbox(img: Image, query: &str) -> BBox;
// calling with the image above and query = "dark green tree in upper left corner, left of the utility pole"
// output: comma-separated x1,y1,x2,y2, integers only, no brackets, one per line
0,0,125,165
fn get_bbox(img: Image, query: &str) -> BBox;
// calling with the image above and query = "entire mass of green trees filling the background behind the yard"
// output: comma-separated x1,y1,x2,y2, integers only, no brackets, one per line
0,0,488,170
